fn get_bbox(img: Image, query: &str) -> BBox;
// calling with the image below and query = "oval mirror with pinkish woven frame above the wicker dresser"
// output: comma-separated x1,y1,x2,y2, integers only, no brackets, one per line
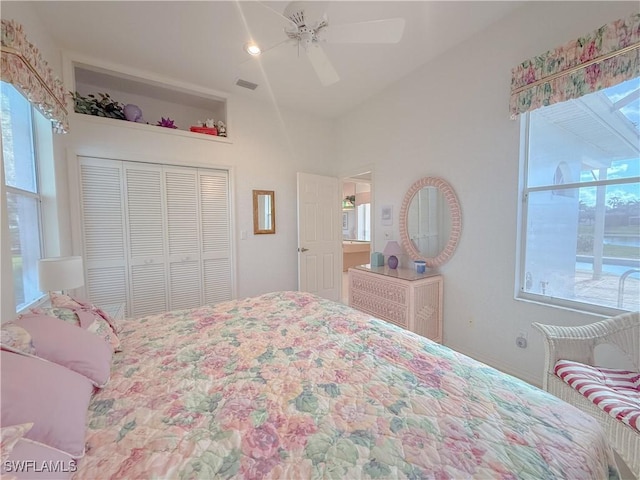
400,177,462,268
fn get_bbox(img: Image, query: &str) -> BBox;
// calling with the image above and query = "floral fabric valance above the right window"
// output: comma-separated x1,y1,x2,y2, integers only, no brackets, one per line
509,14,640,118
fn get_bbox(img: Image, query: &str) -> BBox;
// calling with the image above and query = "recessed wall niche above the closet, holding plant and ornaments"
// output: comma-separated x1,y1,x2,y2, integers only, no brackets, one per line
69,60,233,143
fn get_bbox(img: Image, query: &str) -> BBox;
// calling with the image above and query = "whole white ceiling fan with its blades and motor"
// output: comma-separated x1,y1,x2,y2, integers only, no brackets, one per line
245,1,405,86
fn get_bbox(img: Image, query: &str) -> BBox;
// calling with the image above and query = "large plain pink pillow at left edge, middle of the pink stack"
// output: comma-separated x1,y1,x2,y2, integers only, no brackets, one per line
0,350,93,458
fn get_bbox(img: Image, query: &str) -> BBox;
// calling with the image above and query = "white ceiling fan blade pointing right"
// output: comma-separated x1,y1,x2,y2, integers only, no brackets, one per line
322,18,405,43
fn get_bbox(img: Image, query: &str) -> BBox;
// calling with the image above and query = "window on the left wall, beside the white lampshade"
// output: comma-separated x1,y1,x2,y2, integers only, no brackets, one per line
0,82,42,311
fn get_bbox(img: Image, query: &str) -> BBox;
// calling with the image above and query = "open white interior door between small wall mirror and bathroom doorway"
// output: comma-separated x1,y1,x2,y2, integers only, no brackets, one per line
298,173,342,302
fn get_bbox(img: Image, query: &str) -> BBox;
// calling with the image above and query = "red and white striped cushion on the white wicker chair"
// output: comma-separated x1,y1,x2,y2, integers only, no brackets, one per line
554,360,640,432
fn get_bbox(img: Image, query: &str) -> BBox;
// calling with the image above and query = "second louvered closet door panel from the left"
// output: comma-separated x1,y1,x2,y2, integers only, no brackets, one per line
124,162,169,317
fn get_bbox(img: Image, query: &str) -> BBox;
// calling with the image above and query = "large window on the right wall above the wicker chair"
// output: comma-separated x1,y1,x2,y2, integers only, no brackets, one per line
518,78,640,315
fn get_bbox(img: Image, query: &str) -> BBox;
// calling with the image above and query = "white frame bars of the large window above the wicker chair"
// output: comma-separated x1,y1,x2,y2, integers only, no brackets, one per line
515,112,640,317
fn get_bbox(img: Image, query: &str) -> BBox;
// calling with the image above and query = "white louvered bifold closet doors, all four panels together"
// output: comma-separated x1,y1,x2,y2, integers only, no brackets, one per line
80,157,234,317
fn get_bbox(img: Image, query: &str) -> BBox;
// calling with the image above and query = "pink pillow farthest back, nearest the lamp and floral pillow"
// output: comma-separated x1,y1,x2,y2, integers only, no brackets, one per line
14,313,112,388
